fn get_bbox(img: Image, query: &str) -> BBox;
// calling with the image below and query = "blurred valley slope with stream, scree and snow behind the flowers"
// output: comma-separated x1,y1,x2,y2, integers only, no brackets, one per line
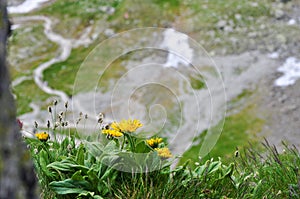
8,0,300,161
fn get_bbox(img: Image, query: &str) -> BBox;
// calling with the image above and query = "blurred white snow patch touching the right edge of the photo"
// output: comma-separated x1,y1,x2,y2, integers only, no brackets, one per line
275,57,300,87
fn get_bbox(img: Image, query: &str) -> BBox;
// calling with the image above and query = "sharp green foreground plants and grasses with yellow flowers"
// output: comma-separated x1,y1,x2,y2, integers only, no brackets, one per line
26,103,300,199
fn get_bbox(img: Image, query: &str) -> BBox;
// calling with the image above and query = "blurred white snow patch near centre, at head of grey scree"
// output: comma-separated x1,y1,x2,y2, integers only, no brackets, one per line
161,29,193,67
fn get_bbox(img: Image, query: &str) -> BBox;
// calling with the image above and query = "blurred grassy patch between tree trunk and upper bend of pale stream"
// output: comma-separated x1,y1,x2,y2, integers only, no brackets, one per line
8,22,58,79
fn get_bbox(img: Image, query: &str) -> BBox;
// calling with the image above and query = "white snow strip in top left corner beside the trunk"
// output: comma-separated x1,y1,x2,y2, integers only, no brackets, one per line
7,0,49,14
